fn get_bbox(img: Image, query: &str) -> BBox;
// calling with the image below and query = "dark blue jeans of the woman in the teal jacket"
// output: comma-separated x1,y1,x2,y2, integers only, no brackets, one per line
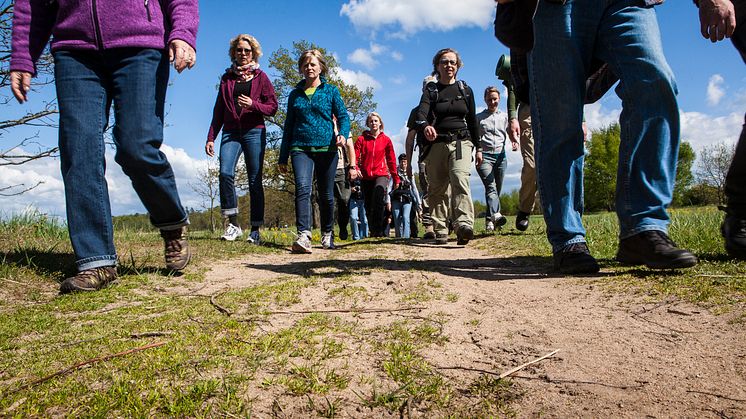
290,151,339,233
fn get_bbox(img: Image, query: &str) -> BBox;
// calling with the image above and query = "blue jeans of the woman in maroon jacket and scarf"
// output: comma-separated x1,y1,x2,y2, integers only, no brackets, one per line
219,128,267,226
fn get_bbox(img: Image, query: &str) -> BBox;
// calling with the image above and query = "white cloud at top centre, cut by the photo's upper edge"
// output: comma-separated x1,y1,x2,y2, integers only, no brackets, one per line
339,0,495,36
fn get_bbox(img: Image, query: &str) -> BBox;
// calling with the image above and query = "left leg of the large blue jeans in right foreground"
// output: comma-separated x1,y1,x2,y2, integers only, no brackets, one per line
529,0,606,252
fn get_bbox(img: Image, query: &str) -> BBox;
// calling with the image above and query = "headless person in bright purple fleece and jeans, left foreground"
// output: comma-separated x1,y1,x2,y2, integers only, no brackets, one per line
10,0,199,293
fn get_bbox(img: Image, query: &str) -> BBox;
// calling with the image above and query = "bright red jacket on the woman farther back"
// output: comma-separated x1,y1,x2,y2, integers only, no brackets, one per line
355,131,399,185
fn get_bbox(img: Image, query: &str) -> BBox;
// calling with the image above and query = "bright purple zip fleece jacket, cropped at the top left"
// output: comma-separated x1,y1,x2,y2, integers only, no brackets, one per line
10,0,199,74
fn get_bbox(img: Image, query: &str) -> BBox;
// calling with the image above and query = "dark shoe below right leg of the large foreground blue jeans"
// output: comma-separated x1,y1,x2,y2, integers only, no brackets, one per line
616,230,698,269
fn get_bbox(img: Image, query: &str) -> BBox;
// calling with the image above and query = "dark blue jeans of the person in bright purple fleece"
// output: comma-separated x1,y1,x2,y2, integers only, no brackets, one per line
54,48,189,270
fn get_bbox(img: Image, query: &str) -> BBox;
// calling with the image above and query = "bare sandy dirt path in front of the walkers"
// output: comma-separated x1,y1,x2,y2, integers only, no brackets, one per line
200,238,746,418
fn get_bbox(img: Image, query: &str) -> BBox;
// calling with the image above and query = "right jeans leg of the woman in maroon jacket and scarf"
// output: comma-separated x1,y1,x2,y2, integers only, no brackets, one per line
241,128,267,227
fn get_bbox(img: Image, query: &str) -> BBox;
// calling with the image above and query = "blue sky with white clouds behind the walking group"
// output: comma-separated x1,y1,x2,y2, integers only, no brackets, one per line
0,0,746,221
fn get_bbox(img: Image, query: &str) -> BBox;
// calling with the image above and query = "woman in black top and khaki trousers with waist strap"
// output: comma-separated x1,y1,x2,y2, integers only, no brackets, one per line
416,48,482,245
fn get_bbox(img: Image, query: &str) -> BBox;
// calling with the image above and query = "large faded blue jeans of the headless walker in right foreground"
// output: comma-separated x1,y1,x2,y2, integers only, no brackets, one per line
529,0,680,252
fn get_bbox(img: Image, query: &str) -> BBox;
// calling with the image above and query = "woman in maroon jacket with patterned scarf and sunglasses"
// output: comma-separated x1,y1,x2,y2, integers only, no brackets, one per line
205,34,277,244
